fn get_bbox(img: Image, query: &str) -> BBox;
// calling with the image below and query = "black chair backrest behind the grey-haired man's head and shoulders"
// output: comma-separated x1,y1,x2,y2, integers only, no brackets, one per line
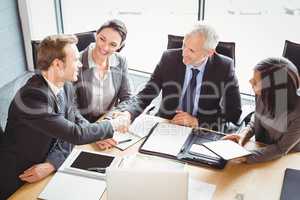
167,35,235,63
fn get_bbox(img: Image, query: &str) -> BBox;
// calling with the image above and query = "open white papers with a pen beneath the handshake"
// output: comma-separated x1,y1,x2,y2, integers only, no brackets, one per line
113,114,166,150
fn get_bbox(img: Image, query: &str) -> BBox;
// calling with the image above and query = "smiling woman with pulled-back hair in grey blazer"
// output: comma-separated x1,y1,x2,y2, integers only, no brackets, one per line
75,20,130,122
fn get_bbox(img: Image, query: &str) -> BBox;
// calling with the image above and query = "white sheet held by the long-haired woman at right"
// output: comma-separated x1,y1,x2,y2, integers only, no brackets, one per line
202,140,251,160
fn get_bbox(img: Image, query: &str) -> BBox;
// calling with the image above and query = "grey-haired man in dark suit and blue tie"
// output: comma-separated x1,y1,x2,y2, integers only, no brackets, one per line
110,23,241,133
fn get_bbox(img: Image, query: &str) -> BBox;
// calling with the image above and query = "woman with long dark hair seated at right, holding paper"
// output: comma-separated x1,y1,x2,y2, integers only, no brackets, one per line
224,58,300,163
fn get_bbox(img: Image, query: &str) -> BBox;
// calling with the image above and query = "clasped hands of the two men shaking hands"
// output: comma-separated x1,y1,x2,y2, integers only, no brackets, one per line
111,111,131,133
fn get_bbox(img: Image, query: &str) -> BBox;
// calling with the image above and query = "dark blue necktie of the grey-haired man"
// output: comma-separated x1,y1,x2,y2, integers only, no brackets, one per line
182,69,199,114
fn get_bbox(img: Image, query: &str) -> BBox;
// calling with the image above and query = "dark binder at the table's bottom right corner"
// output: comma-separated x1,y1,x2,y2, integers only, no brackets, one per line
280,168,300,200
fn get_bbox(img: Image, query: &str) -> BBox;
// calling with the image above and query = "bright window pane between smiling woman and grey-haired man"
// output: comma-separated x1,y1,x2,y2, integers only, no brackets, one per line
61,0,198,73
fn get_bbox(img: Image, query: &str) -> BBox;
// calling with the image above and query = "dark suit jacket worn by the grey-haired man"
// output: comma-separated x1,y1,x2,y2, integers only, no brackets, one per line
127,49,241,129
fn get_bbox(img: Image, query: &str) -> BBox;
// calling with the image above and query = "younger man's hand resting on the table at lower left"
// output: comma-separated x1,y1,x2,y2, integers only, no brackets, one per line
19,162,55,183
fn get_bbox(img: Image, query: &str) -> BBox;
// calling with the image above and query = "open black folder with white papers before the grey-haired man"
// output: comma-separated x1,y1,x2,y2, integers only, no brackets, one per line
139,123,251,169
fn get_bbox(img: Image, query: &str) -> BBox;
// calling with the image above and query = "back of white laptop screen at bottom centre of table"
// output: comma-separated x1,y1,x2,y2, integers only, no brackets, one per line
106,168,188,200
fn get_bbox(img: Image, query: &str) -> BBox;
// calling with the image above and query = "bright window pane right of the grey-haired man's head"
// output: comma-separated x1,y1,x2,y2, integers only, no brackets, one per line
205,0,300,93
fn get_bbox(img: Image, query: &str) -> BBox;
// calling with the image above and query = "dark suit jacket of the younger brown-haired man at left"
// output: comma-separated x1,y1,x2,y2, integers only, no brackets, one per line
0,74,113,199
